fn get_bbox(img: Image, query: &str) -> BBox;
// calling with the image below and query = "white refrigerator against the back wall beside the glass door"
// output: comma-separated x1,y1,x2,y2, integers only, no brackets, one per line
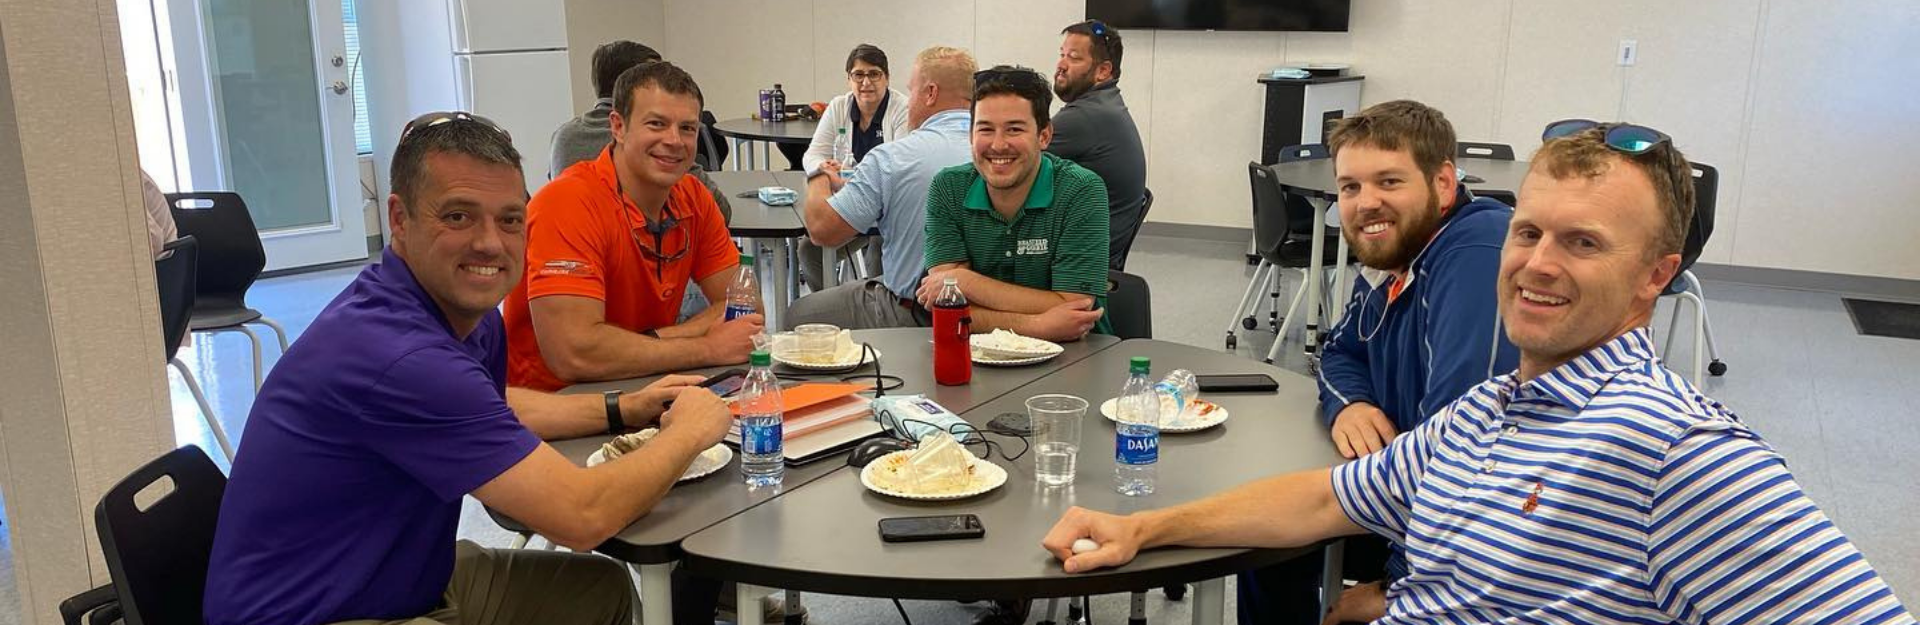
447,0,576,194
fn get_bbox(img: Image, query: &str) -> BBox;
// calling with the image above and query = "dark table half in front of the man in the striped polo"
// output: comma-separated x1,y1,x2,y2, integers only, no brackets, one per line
682,341,1340,625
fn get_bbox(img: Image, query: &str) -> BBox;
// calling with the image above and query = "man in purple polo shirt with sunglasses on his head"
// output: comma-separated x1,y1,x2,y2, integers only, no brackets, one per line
205,113,730,625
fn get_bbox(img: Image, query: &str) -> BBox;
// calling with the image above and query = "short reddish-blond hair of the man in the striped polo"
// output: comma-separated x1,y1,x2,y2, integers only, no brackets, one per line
1528,127,1693,255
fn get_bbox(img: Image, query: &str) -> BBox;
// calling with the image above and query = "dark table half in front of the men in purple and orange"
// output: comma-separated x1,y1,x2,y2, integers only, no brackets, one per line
503,329,1119,623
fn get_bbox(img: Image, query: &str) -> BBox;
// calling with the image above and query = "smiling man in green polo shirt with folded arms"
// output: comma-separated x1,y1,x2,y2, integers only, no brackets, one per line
916,65,1112,341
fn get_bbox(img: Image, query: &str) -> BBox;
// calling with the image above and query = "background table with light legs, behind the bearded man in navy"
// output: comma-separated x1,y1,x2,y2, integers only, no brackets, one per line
1267,157,1526,362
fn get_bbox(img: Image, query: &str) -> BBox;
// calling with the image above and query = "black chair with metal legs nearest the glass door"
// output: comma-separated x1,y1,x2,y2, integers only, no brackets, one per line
167,192,286,391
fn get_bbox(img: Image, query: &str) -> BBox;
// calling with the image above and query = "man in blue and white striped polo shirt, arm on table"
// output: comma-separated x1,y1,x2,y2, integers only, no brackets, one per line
1043,121,1914,625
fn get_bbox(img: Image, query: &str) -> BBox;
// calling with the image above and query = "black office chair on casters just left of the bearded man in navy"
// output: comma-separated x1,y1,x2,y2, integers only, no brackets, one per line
1227,155,1342,351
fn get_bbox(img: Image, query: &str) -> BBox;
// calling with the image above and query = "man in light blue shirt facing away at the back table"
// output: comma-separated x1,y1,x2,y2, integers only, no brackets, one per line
787,46,975,330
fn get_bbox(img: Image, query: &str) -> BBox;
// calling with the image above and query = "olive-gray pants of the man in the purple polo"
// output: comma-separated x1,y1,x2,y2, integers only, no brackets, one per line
338,541,634,625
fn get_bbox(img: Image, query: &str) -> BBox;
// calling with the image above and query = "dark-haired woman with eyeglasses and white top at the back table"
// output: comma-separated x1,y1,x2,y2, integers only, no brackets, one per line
801,44,912,176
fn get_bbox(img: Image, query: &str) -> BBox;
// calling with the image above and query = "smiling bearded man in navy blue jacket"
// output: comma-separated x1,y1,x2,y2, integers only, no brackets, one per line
1240,100,1519,623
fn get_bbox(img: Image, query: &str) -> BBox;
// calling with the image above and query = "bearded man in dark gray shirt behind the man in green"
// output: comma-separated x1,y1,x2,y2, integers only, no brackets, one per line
1046,19,1146,270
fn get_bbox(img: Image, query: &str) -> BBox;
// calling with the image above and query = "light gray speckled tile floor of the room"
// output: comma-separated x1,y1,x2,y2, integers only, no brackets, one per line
0,236,1920,625
